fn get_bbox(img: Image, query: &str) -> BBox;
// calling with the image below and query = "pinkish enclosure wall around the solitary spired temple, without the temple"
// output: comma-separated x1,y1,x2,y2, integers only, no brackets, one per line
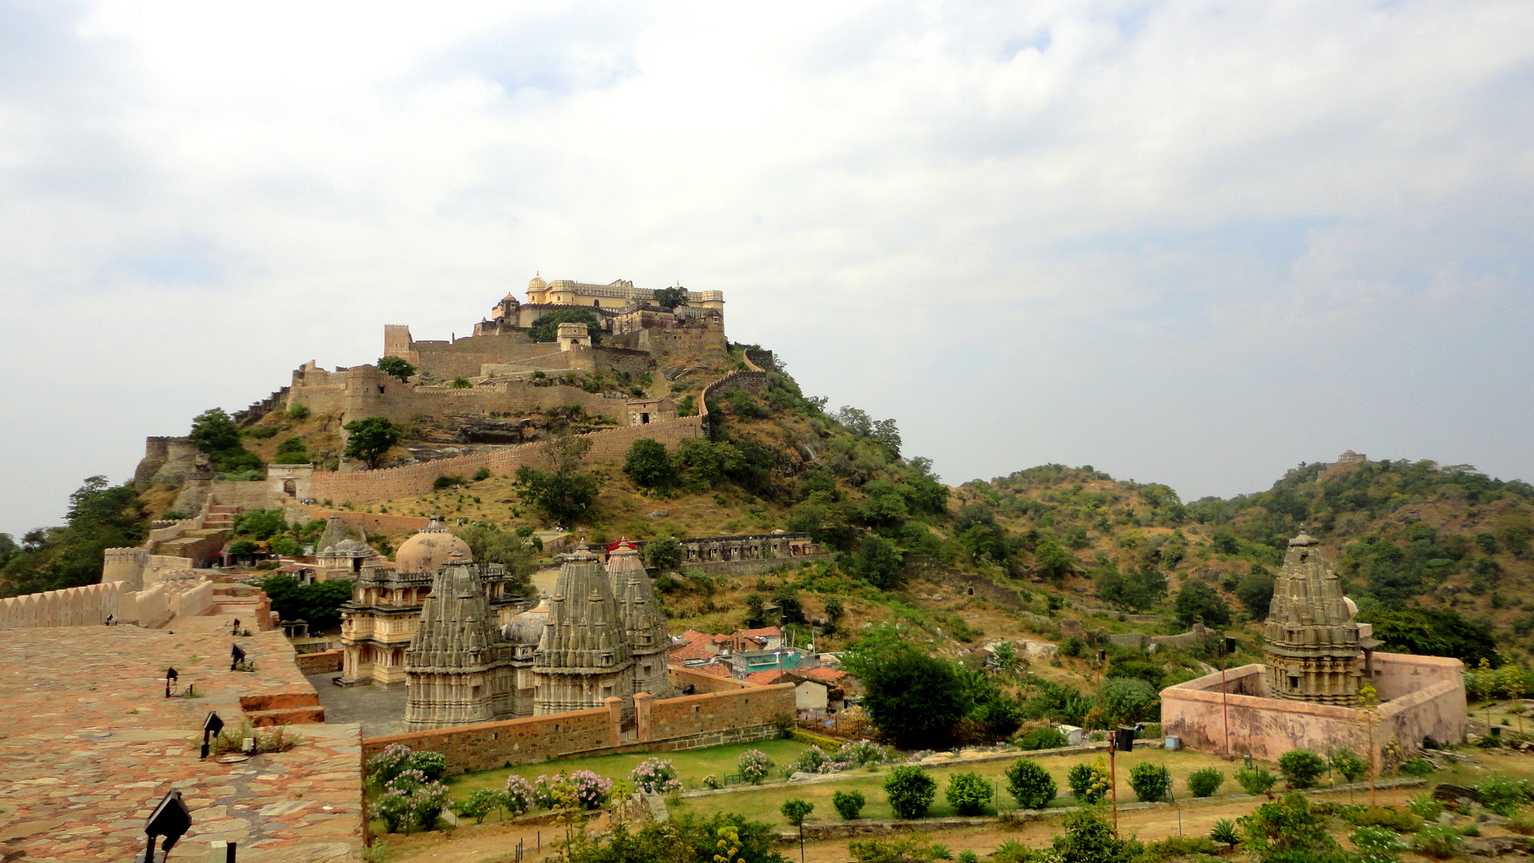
1161,653,1465,760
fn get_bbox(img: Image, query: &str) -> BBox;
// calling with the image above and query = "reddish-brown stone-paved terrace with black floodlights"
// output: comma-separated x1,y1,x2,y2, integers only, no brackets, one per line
0,607,362,863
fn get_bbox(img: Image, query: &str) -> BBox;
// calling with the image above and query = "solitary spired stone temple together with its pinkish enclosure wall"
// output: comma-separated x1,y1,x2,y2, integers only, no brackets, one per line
1161,533,1465,760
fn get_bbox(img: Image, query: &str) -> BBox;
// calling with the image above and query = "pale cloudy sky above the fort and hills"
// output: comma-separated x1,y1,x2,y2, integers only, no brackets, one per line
0,0,1534,535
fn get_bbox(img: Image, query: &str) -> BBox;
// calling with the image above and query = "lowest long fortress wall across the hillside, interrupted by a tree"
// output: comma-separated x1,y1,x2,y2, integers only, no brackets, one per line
310,417,704,504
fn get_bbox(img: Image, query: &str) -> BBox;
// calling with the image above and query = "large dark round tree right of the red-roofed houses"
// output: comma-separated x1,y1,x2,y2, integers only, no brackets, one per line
844,630,973,750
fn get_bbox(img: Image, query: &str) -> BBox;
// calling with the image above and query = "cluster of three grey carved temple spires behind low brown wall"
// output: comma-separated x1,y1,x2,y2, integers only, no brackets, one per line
405,543,675,731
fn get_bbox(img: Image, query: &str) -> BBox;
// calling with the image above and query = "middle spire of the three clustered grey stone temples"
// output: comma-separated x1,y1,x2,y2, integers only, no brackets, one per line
532,543,634,714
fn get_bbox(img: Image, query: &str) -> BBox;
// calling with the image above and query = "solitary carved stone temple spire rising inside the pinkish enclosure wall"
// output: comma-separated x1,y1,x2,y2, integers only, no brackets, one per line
1262,533,1371,707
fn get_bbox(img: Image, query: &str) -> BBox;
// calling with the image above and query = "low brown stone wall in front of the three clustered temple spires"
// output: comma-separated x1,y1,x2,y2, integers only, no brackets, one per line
362,684,795,774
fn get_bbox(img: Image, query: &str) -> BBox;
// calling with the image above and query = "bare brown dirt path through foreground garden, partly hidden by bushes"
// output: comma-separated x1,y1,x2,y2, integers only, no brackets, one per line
385,788,1422,863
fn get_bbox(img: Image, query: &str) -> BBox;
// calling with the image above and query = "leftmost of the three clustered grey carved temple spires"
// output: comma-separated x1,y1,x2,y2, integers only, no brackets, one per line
405,553,517,731
